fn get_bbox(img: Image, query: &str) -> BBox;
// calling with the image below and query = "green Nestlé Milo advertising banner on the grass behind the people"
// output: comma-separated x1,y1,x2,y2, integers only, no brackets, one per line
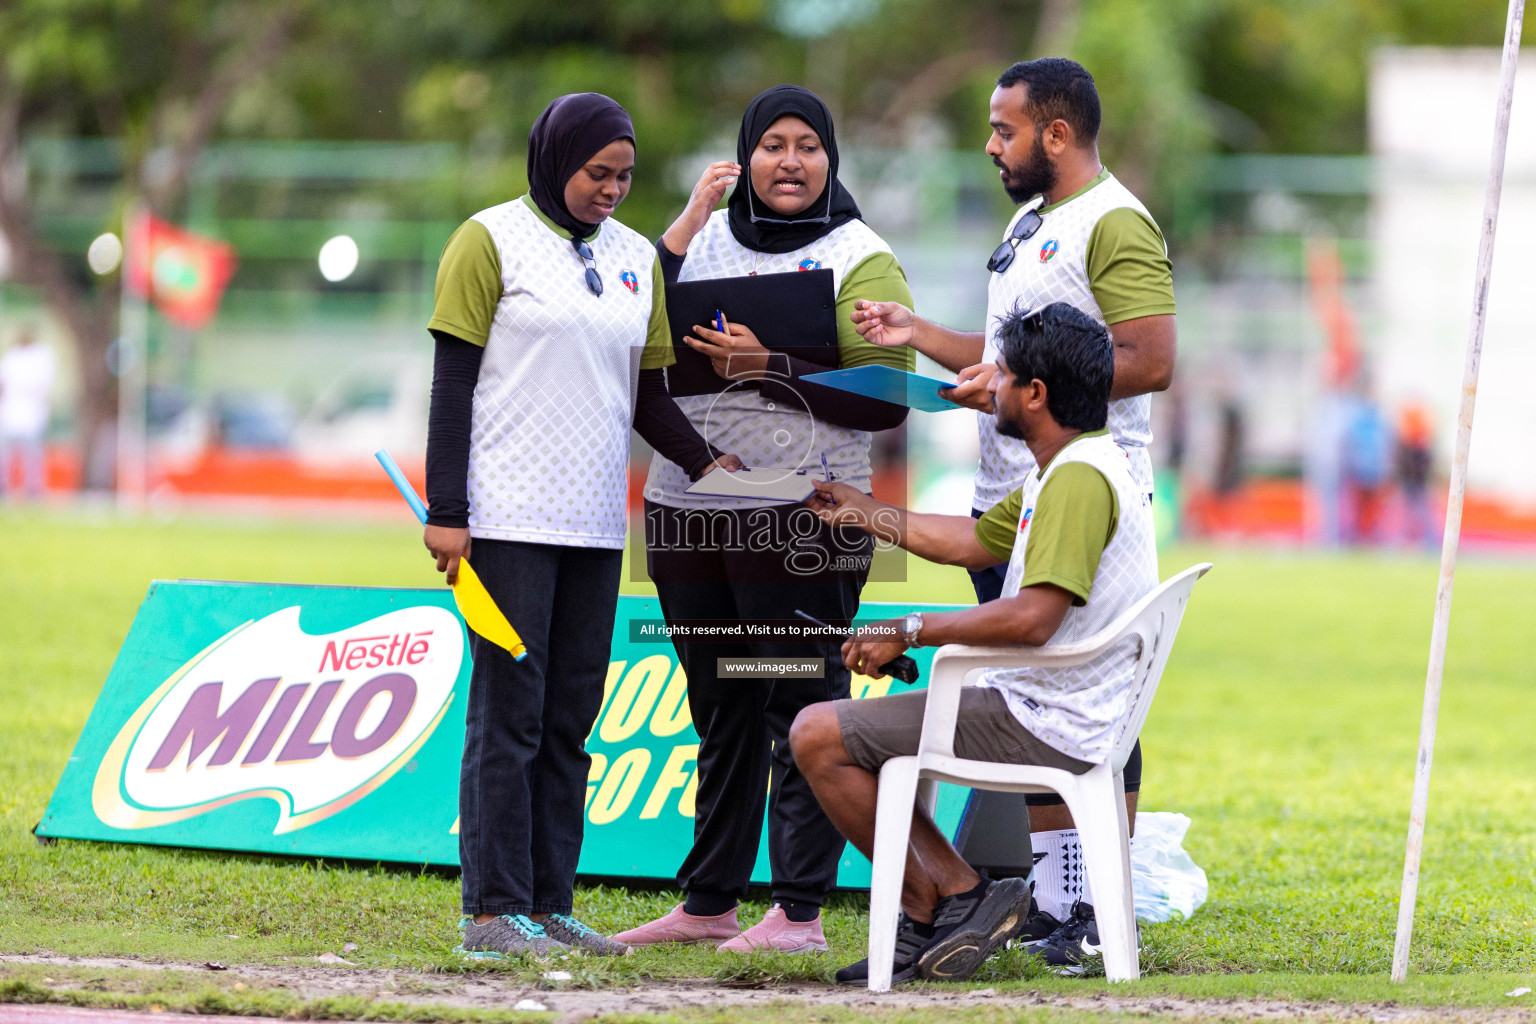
37,582,965,887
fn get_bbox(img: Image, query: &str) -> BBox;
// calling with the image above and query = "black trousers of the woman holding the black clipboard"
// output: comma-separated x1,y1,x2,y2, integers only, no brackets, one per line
645,502,874,904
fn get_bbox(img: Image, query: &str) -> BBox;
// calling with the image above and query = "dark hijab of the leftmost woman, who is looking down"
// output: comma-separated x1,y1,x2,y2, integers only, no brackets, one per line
528,92,634,238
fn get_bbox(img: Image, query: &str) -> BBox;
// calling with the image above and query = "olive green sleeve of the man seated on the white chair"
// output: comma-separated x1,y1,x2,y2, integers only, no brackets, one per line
1018,462,1120,605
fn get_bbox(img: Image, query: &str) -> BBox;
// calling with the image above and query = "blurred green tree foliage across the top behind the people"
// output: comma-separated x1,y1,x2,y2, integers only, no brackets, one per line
0,0,1504,482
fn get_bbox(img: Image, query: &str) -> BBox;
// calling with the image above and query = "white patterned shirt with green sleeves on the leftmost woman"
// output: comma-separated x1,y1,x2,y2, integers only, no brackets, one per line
429,195,673,550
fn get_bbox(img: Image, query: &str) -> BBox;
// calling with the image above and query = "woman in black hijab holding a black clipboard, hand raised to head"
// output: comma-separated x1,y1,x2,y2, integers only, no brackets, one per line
617,86,912,952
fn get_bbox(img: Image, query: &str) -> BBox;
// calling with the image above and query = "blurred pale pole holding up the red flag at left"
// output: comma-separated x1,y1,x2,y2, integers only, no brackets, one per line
117,203,154,514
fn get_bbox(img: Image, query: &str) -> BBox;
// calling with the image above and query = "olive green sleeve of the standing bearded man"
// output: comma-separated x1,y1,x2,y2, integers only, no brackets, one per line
1087,206,1174,324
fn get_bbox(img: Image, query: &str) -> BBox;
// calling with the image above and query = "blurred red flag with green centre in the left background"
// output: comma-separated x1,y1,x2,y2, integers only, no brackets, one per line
124,213,238,330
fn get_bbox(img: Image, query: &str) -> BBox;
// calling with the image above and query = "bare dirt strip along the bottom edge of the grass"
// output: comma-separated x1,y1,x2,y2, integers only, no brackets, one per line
0,953,1536,1024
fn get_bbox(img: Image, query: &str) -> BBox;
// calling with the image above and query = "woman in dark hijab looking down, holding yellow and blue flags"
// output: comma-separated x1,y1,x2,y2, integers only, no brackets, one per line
424,92,739,958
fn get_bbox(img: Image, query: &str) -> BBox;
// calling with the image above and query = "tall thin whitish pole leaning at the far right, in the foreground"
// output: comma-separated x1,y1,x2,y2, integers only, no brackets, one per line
1392,0,1525,981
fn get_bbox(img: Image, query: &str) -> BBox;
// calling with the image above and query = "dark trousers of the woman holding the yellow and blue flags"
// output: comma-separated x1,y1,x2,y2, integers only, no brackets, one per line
459,539,622,913
